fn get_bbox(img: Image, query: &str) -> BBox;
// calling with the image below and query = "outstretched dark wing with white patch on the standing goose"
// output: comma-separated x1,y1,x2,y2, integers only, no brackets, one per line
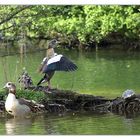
42,54,78,73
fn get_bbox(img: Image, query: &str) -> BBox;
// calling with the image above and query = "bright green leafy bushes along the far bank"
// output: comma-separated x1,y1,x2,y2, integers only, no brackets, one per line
0,5,140,53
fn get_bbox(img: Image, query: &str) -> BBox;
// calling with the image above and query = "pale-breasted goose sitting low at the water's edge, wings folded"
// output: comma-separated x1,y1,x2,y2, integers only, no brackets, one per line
4,82,44,117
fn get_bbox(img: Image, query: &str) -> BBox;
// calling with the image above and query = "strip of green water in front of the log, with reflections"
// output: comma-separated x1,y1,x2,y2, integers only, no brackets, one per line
0,113,140,135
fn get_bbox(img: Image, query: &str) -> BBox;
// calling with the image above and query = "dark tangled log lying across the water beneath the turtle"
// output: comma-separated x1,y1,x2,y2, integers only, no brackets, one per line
0,86,140,116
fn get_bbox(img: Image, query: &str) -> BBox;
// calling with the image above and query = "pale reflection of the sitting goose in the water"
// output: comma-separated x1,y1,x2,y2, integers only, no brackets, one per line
5,118,32,135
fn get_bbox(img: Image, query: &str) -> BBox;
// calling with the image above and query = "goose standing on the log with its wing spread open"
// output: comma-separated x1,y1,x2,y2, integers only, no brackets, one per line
37,39,77,89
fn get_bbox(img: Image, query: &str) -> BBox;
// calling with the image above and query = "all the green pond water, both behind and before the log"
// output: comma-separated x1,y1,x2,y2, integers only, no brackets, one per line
0,49,140,135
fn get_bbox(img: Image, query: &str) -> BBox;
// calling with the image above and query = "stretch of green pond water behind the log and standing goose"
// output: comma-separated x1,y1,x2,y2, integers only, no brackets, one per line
0,50,140,97
